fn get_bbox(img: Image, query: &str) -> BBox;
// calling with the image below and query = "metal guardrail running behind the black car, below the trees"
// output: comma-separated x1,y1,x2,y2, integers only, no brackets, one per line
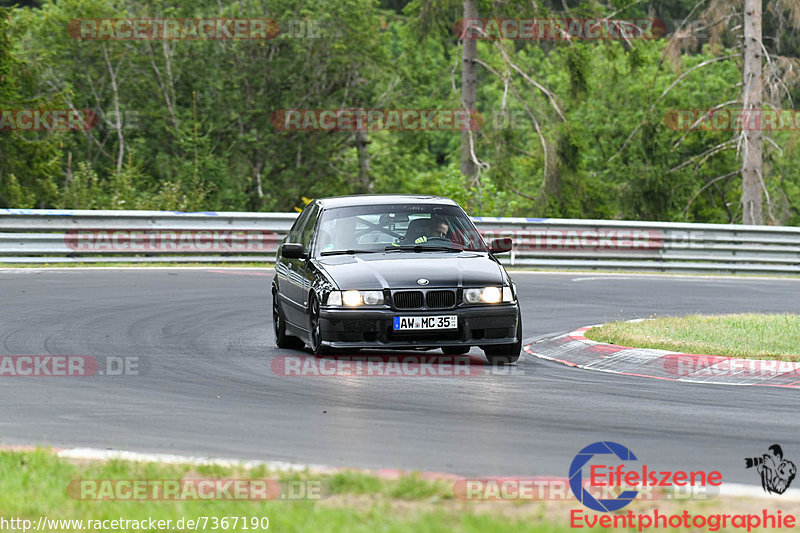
0,209,800,275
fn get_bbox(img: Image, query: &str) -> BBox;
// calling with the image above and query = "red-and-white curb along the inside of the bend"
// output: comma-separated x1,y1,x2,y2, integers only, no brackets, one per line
525,326,800,389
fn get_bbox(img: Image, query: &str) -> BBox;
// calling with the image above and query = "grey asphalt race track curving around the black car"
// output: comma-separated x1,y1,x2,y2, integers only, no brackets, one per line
0,269,800,484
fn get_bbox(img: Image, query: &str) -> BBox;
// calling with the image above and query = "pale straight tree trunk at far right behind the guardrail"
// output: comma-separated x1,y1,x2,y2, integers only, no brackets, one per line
742,0,764,224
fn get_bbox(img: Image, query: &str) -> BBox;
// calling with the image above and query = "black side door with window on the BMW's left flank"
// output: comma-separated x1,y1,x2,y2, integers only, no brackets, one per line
282,204,319,329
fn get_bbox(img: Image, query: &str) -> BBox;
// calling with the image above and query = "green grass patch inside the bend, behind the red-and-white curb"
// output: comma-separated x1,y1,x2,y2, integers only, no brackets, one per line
586,314,800,360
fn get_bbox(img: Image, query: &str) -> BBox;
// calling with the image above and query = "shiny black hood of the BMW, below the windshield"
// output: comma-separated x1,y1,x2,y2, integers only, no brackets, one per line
317,252,505,290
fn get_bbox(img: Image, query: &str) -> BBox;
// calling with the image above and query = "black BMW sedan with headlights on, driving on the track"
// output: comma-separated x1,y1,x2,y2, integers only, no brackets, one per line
272,195,522,364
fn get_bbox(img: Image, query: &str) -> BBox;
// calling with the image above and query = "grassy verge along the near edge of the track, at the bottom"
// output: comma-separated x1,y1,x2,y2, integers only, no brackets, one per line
0,449,800,533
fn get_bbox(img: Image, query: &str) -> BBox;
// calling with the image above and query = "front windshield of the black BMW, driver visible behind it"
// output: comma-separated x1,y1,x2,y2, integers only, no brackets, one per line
314,204,488,256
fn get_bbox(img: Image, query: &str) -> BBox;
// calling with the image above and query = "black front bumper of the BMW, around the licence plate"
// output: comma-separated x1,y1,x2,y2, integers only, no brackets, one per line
320,303,519,349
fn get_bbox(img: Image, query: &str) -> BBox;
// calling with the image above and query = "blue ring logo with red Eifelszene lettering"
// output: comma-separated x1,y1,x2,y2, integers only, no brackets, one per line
569,441,722,512
